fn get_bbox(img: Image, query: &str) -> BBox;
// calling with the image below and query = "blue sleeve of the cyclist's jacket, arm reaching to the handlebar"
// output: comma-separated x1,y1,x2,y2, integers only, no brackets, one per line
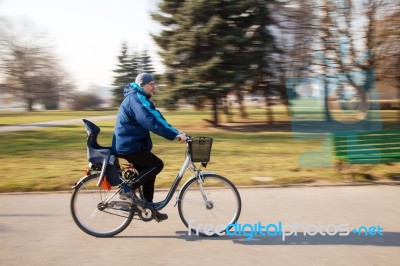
129,92,179,140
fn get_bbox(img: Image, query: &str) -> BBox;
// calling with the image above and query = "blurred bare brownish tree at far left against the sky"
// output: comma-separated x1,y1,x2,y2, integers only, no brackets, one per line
0,19,73,111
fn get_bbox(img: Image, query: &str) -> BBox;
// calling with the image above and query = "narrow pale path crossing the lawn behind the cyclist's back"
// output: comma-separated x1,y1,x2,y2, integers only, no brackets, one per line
0,115,115,133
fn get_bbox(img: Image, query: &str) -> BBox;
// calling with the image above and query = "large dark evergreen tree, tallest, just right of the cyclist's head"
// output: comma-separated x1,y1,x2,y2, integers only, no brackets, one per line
153,0,272,125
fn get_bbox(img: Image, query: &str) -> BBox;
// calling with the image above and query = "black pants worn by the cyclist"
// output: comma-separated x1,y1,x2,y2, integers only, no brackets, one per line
119,150,164,202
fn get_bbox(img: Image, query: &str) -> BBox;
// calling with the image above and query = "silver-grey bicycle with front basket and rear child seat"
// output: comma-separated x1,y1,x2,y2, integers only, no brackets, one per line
70,119,242,237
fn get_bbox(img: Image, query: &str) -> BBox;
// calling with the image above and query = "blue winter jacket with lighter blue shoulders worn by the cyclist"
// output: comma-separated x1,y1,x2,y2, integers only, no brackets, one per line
112,82,179,155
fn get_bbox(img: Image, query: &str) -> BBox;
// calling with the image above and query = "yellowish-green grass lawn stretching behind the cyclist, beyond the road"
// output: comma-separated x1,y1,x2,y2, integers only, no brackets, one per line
0,107,400,192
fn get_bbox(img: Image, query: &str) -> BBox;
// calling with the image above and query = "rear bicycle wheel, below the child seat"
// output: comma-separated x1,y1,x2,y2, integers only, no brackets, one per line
70,174,134,237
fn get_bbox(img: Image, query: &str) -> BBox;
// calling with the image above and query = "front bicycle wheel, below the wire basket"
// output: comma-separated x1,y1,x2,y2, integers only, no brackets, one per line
178,174,242,236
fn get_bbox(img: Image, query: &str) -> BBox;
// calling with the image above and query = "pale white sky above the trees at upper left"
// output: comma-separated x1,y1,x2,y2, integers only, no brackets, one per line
0,0,163,90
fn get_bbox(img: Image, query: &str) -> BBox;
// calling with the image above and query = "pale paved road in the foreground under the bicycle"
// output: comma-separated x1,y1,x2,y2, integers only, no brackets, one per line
0,185,400,266
